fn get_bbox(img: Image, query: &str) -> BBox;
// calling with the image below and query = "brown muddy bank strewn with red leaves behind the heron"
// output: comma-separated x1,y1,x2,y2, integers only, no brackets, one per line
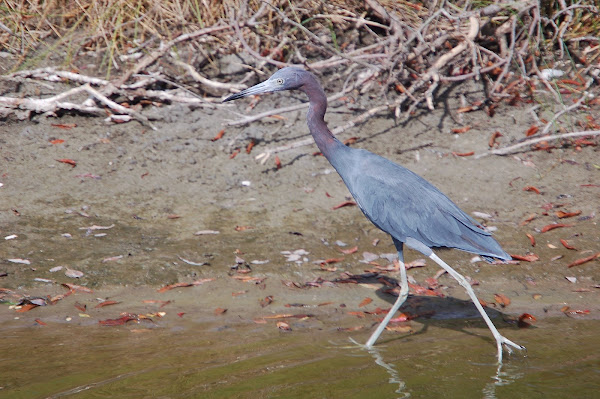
0,76,600,334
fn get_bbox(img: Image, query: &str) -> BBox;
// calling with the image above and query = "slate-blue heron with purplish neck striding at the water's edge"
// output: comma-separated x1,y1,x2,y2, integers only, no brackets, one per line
224,67,525,363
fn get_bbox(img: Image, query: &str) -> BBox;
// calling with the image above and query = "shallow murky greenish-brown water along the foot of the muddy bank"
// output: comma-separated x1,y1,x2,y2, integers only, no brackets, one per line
0,318,600,398
